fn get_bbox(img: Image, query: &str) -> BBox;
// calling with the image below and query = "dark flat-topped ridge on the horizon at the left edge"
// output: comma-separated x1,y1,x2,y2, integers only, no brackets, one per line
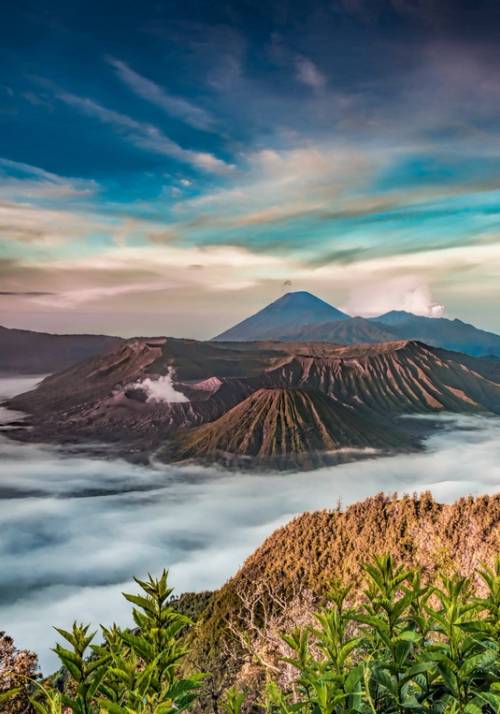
0,326,122,374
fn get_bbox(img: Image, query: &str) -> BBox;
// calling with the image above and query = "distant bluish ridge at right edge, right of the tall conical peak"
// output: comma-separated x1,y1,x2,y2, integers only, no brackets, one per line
370,310,500,357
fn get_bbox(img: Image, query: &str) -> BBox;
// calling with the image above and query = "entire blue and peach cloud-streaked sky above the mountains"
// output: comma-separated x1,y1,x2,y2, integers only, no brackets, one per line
0,0,500,338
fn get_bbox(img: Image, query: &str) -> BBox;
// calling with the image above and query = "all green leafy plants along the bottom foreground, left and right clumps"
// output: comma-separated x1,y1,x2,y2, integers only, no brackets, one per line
0,555,500,714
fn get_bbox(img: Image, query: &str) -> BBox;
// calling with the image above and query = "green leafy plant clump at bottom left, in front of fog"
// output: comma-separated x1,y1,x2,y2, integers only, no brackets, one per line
32,571,203,714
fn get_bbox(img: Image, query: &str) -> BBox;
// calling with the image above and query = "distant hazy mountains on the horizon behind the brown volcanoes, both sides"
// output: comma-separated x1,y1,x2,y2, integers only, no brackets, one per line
0,292,500,374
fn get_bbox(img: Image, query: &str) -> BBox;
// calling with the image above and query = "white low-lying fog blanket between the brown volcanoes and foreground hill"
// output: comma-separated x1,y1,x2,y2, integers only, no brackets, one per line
0,378,500,673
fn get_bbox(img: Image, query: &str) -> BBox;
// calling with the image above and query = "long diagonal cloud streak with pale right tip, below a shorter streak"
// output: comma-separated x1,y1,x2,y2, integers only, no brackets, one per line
58,92,234,174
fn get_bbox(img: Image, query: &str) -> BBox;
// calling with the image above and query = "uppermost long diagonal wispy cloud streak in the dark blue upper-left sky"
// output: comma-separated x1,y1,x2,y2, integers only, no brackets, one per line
108,57,215,131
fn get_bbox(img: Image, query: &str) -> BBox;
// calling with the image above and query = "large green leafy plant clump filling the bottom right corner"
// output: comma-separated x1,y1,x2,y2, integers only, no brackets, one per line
242,556,500,714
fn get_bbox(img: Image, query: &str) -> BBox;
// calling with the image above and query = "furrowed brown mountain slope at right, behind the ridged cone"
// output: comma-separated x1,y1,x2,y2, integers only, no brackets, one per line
267,341,500,416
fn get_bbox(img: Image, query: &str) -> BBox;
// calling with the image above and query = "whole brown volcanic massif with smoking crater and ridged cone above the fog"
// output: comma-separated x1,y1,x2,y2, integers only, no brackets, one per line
5,338,500,468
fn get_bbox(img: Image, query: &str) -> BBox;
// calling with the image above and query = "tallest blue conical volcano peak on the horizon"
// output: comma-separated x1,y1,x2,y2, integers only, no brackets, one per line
213,292,349,342
